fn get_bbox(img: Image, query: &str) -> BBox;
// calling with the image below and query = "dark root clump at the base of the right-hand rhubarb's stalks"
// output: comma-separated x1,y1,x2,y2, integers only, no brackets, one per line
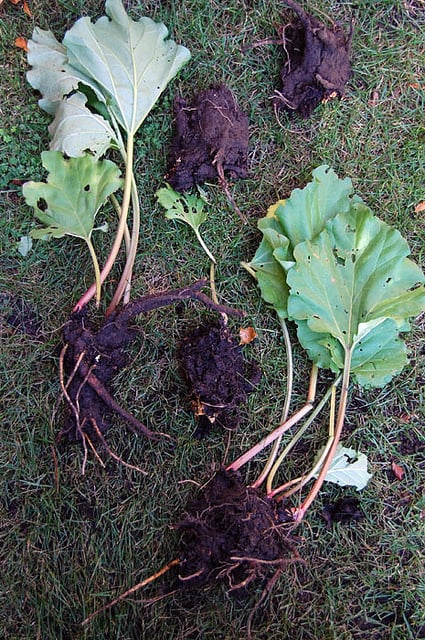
178,469,299,595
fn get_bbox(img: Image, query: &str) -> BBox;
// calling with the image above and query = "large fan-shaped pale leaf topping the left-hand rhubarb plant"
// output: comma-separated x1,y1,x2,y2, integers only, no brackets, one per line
63,0,190,134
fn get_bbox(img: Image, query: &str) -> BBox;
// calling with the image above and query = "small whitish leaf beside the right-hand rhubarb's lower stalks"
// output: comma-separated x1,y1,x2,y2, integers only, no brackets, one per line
316,444,372,491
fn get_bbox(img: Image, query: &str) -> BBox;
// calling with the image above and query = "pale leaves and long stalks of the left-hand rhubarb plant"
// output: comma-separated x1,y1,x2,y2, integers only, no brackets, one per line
24,0,190,314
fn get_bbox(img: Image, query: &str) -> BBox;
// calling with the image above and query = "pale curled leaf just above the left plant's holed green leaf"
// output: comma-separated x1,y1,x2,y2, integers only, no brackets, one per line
49,91,116,157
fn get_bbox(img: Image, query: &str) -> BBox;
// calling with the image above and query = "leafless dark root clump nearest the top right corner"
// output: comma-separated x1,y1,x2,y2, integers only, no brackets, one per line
274,0,352,118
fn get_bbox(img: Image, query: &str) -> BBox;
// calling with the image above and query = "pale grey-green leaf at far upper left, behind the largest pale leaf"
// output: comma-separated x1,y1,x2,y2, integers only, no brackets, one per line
27,27,78,115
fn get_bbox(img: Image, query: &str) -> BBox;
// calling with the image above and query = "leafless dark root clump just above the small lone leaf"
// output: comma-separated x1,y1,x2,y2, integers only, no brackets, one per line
166,85,249,192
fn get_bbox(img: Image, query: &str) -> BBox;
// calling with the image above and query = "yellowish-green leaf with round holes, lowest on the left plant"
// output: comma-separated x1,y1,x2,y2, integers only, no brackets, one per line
23,151,122,241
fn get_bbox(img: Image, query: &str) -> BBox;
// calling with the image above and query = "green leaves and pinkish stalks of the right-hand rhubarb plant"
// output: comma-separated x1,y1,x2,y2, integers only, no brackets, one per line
235,166,425,520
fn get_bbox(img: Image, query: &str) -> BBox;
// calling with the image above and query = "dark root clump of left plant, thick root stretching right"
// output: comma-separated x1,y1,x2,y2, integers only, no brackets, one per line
60,280,243,441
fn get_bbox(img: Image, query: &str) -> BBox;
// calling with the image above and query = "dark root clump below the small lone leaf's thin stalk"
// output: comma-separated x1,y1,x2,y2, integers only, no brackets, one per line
179,320,261,438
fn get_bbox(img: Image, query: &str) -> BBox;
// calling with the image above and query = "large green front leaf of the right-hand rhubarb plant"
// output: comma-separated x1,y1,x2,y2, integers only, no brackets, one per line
287,204,425,386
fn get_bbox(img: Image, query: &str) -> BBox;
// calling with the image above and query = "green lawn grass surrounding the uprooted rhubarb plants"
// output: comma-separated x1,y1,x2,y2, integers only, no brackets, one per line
0,0,425,640
